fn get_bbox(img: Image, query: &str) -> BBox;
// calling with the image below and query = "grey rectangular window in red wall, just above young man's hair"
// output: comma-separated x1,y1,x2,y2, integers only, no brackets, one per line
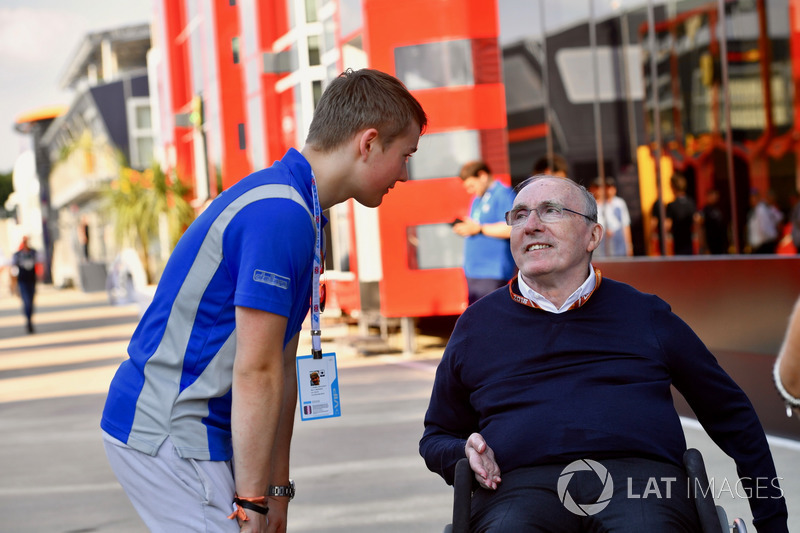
394,40,475,91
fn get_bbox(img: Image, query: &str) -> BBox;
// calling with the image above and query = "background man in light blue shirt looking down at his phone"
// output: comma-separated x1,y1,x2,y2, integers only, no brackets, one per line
453,161,516,305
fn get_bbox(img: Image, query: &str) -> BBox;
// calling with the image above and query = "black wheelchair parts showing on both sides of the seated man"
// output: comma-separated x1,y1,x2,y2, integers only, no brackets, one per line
444,448,747,533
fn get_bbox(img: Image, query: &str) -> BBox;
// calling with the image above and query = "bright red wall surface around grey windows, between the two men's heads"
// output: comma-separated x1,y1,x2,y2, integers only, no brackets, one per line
364,0,508,316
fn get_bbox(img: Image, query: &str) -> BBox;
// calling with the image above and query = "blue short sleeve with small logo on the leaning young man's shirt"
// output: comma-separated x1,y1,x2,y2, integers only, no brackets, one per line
223,198,315,317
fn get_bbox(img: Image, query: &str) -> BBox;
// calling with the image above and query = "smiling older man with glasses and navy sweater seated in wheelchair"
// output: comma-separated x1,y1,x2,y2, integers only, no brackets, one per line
420,175,788,533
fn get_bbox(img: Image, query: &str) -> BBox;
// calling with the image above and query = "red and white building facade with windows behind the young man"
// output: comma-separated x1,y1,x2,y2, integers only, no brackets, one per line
154,0,509,317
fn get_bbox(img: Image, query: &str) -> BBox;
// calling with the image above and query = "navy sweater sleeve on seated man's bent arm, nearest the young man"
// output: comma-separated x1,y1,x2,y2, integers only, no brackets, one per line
419,320,479,485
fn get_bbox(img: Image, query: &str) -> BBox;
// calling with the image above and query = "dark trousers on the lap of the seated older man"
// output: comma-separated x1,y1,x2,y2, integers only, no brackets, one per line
470,459,701,533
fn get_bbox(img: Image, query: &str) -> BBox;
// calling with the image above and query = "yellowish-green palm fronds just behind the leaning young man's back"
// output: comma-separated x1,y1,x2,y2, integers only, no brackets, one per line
103,163,194,279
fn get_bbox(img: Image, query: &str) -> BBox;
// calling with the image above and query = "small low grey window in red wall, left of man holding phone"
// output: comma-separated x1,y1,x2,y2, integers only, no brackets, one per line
406,224,464,270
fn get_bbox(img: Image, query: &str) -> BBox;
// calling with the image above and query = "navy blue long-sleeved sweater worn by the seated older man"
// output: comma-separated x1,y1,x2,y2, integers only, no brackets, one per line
420,279,787,532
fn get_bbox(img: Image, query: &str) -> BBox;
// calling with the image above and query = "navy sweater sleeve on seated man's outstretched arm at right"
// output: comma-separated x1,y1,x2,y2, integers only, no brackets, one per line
651,302,788,533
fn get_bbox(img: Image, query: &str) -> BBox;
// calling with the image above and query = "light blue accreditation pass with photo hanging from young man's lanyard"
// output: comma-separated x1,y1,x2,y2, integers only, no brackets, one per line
297,353,342,421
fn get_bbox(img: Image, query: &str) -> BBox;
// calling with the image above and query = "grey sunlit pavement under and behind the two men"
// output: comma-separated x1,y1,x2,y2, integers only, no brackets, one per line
0,286,800,533
